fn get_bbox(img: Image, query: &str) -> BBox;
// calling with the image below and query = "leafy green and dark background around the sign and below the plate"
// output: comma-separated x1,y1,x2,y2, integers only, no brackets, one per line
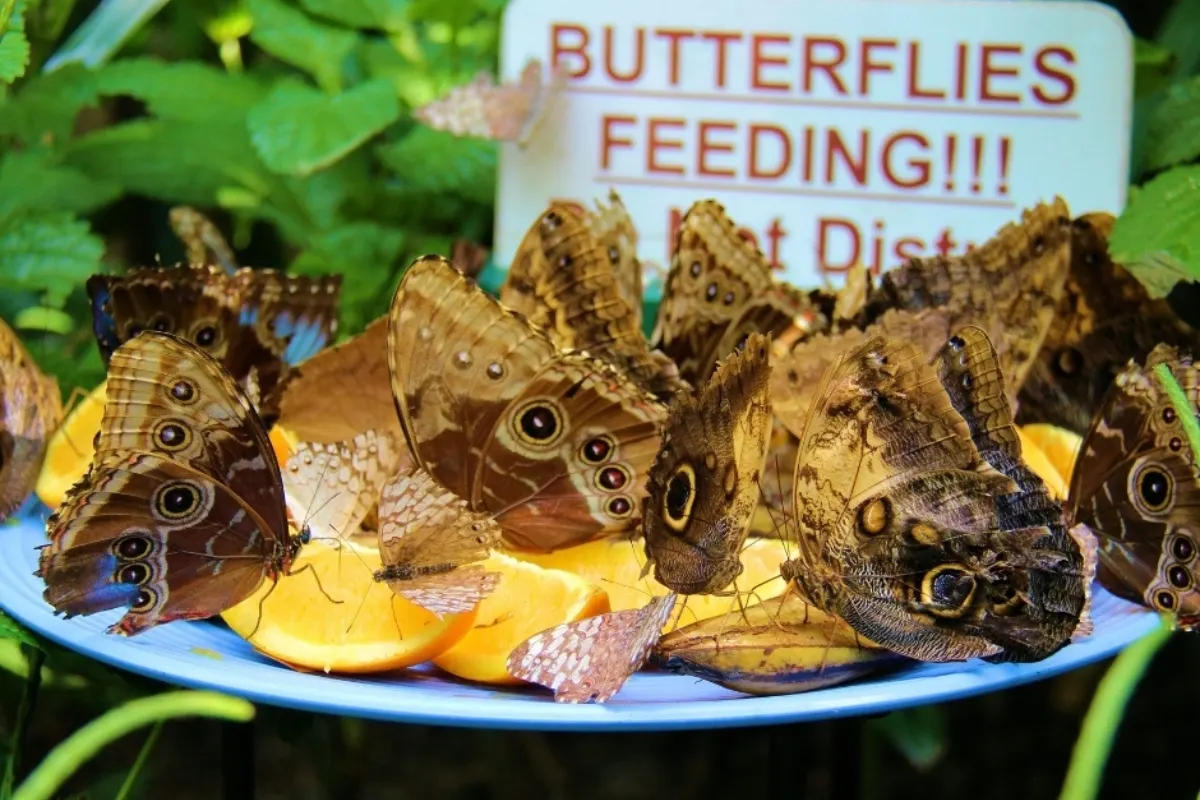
0,0,1200,800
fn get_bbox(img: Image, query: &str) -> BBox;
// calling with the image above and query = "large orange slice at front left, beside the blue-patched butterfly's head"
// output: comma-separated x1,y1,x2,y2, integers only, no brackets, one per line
222,540,475,673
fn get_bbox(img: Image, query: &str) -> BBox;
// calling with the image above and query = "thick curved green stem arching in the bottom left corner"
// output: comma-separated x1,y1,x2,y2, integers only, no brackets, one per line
13,692,254,800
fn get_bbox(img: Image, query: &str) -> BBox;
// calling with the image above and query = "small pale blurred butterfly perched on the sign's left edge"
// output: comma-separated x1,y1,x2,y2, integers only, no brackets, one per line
413,59,566,148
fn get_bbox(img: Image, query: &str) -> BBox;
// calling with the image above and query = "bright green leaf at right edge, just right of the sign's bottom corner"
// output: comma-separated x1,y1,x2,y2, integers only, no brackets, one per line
1109,167,1200,296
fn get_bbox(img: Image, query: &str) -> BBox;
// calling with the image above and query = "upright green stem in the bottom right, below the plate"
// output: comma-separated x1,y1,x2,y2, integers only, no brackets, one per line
1058,619,1174,800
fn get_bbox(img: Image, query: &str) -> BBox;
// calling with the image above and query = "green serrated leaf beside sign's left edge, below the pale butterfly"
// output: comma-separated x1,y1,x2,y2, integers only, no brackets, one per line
378,126,497,203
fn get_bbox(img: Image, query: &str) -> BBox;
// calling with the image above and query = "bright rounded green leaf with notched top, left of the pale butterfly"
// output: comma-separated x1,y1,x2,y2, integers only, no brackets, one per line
246,80,400,175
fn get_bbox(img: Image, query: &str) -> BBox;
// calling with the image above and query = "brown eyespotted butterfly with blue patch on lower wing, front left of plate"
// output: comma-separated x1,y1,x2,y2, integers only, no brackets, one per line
38,331,308,636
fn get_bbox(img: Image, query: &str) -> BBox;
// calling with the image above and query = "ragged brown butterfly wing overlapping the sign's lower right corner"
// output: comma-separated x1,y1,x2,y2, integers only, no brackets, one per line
859,198,1072,397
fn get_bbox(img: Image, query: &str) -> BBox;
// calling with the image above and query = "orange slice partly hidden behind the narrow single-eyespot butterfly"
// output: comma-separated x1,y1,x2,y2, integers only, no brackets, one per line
515,539,794,631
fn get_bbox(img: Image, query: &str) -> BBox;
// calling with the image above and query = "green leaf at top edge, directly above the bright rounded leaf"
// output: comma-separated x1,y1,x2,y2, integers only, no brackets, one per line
247,0,359,91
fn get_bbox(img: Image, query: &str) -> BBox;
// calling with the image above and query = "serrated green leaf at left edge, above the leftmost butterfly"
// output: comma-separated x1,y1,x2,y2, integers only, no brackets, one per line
0,213,104,307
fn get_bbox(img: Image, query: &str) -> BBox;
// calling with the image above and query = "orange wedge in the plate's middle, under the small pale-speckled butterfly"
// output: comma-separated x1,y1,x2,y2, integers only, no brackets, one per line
433,553,610,685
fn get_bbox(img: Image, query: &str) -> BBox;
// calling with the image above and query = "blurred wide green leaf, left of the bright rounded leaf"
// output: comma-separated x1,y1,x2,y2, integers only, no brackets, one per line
96,58,266,122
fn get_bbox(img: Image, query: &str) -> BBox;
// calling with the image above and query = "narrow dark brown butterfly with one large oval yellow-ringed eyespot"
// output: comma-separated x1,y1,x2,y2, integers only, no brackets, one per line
642,333,772,595
